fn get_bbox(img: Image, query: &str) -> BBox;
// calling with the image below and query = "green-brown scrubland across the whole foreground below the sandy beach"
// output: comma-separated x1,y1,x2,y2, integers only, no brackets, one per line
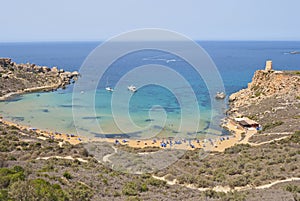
0,123,300,201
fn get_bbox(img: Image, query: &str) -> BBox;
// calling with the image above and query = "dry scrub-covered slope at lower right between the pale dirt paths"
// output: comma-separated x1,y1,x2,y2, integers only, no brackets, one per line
158,131,300,188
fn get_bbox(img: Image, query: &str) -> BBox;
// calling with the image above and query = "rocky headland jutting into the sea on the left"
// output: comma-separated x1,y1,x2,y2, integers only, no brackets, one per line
0,58,79,99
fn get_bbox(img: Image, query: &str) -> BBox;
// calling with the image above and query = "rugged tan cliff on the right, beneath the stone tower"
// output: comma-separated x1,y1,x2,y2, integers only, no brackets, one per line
228,70,300,132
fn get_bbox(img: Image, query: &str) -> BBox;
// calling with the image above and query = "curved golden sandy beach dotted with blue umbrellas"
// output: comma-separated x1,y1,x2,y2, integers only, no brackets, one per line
2,116,257,152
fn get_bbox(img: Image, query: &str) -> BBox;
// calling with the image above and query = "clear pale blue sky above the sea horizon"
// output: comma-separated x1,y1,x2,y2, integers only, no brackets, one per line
0,0,300,42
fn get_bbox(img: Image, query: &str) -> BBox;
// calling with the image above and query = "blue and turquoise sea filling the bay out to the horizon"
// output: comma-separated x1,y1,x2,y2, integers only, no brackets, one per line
0,41,300,138
